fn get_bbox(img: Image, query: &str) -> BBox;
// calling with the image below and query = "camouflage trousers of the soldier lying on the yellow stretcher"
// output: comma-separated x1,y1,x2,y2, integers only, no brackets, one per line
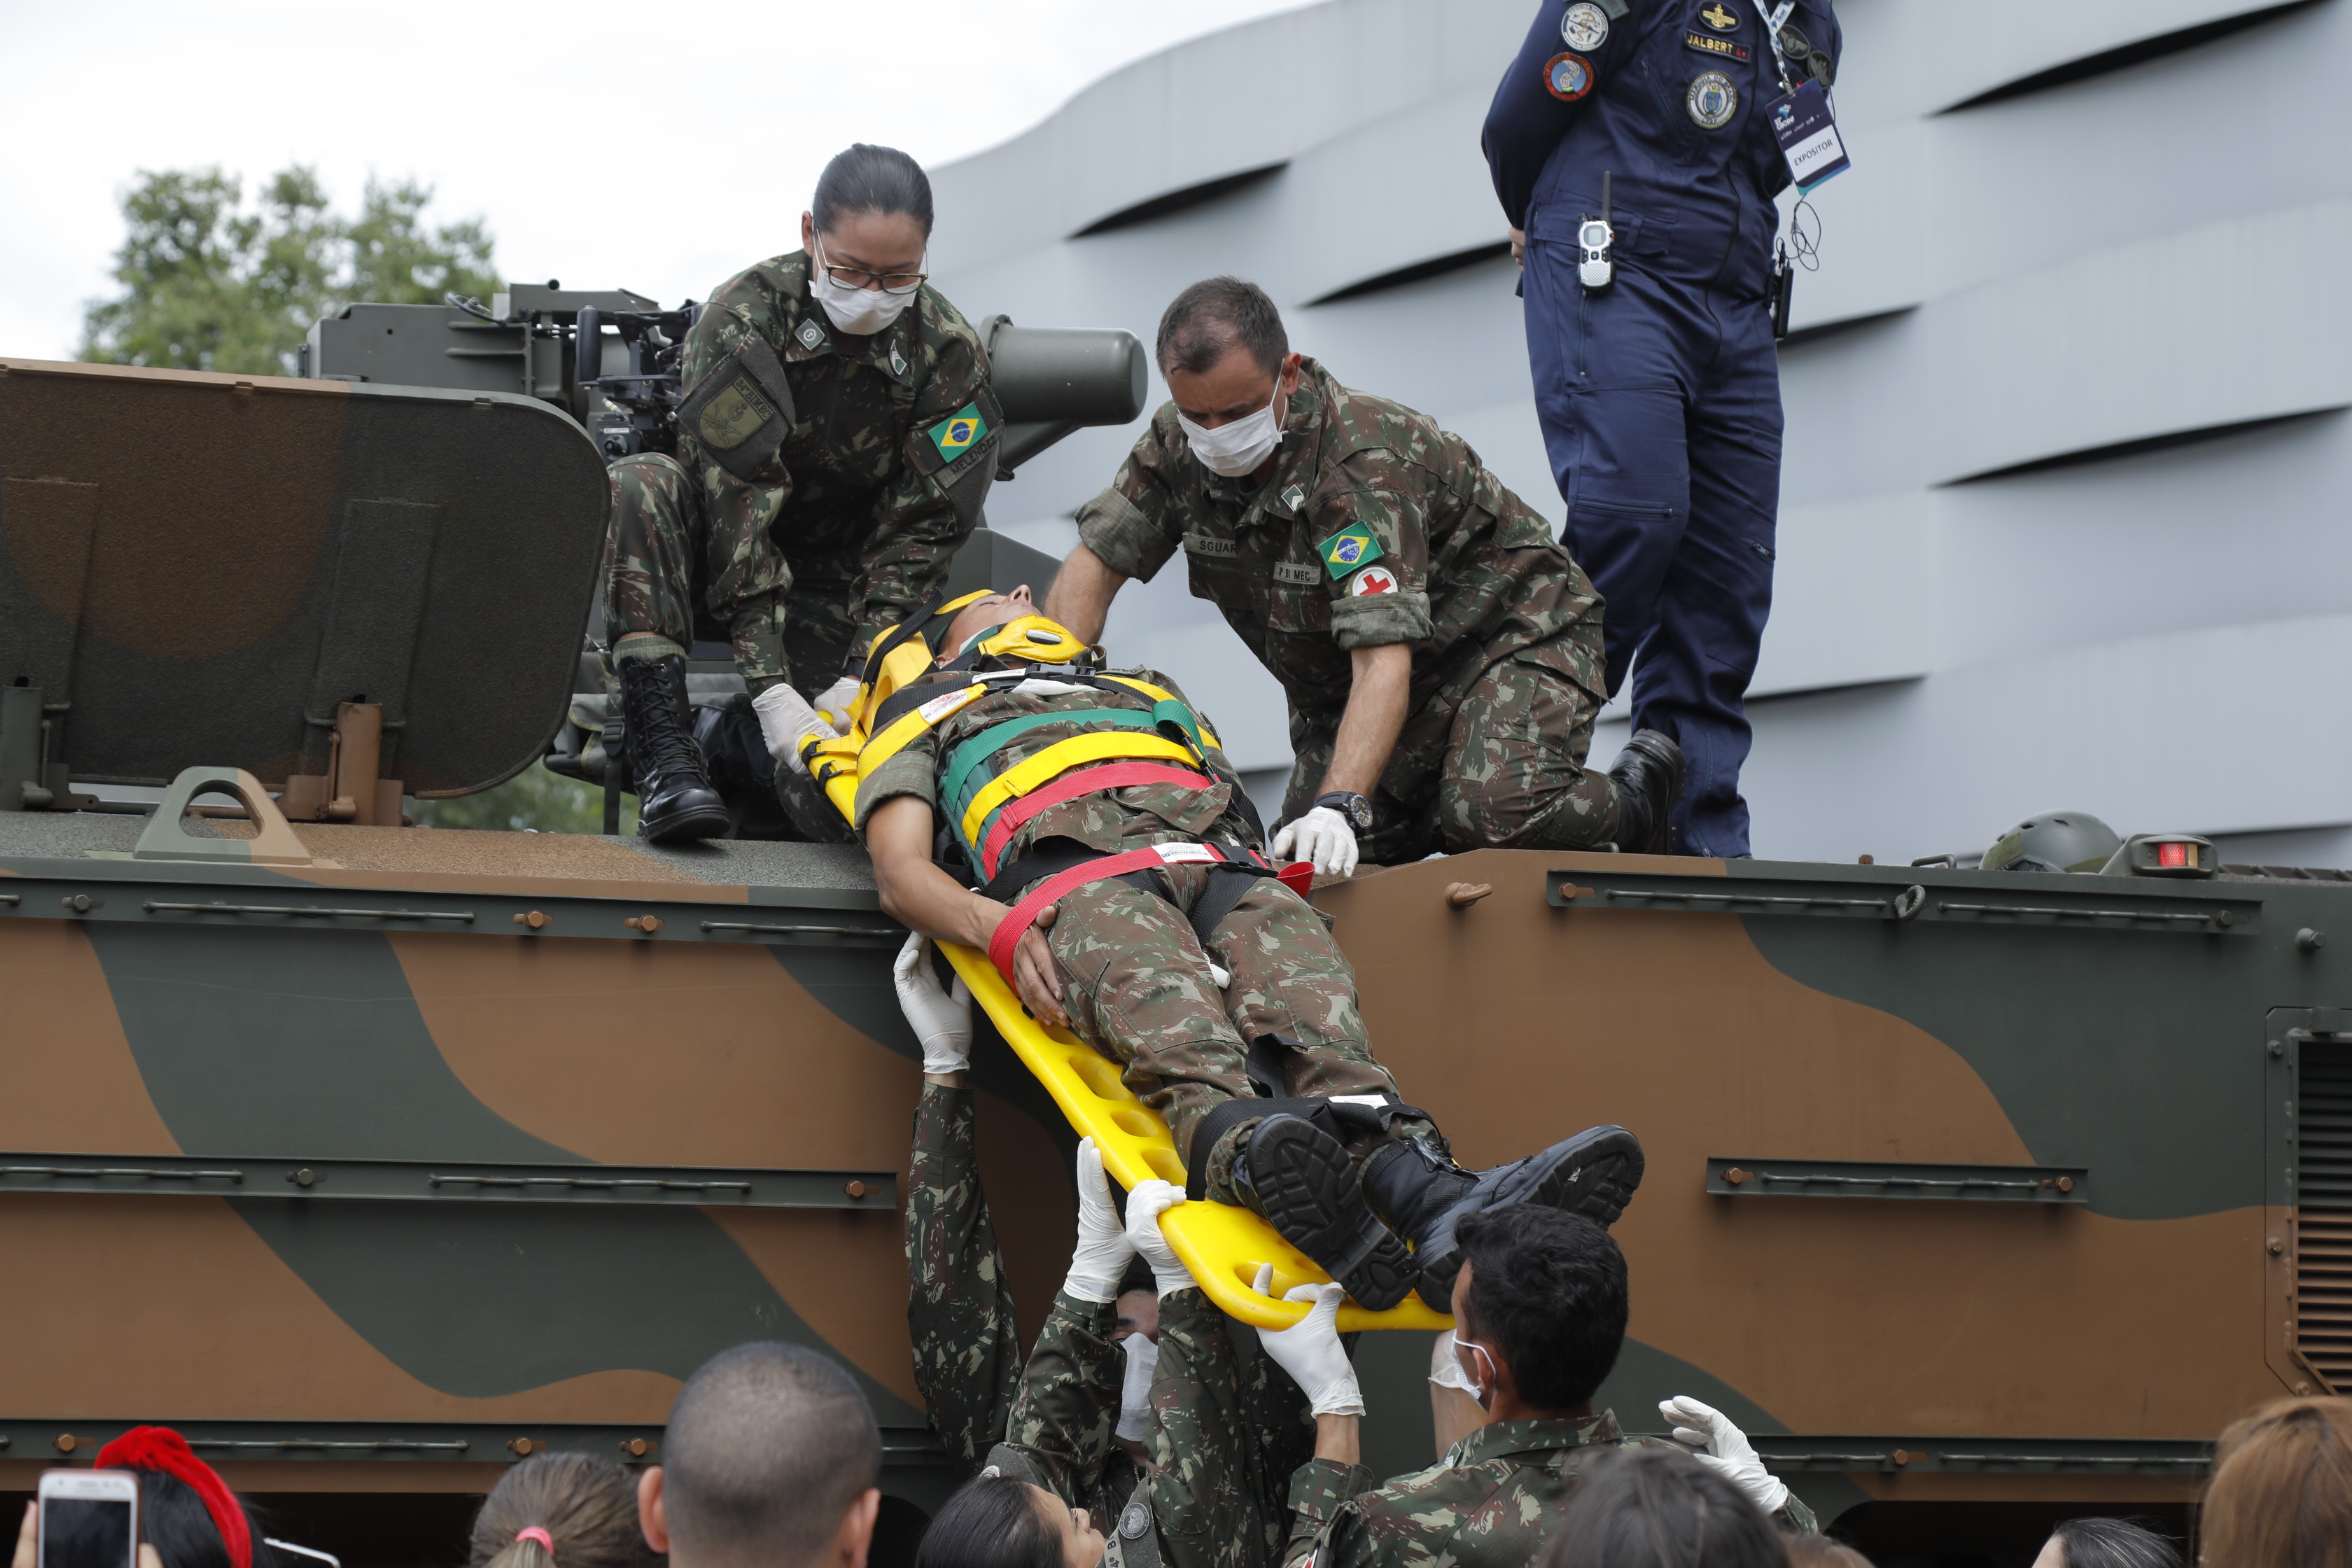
1046,865,1409,1203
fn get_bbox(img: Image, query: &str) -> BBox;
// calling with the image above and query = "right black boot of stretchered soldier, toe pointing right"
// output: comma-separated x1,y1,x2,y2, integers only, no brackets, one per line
1373,1126,1642,1312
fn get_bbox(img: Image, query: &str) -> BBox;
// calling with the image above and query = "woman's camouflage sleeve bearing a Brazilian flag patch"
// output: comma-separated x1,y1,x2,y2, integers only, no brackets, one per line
849,312,1004,668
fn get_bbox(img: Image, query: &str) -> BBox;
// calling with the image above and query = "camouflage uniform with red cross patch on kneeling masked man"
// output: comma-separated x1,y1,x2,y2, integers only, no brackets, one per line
1077,360,1618,863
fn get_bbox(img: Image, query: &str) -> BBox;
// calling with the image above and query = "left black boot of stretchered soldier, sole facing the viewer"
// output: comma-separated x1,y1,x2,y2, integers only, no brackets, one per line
1233,1114,1416,1312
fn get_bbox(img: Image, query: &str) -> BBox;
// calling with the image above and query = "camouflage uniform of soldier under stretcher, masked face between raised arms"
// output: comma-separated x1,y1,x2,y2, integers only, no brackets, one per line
1007,1288,1315,1568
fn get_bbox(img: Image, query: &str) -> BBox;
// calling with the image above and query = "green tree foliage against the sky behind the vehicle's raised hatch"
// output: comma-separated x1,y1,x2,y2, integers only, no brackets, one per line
80,164,498,376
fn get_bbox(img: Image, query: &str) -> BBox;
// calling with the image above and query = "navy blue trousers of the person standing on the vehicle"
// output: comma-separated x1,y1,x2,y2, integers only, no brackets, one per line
1524,235,1781,855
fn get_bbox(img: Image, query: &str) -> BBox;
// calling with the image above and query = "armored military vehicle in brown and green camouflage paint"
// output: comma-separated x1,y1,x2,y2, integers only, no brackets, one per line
0,315,2352,1566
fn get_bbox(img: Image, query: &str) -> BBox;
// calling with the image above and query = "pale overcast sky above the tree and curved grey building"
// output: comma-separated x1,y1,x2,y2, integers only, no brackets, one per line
0,0,1326,360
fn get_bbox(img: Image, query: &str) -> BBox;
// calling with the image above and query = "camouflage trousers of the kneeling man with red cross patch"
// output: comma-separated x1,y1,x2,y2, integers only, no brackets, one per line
1282,625,1618,865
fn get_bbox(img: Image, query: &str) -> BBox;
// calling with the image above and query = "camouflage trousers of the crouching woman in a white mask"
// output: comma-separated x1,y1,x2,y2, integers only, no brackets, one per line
605,451,856,698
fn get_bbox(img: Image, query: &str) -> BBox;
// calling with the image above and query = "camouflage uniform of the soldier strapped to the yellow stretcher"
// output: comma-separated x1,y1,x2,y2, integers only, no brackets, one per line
856,670,1425,1203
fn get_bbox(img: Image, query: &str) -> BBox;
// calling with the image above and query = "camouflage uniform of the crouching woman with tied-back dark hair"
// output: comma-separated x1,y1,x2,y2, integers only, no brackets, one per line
605,251,1002,696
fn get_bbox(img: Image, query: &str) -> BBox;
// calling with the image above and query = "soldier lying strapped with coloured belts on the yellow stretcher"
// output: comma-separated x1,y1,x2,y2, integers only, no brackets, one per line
856,588,1642,1312
